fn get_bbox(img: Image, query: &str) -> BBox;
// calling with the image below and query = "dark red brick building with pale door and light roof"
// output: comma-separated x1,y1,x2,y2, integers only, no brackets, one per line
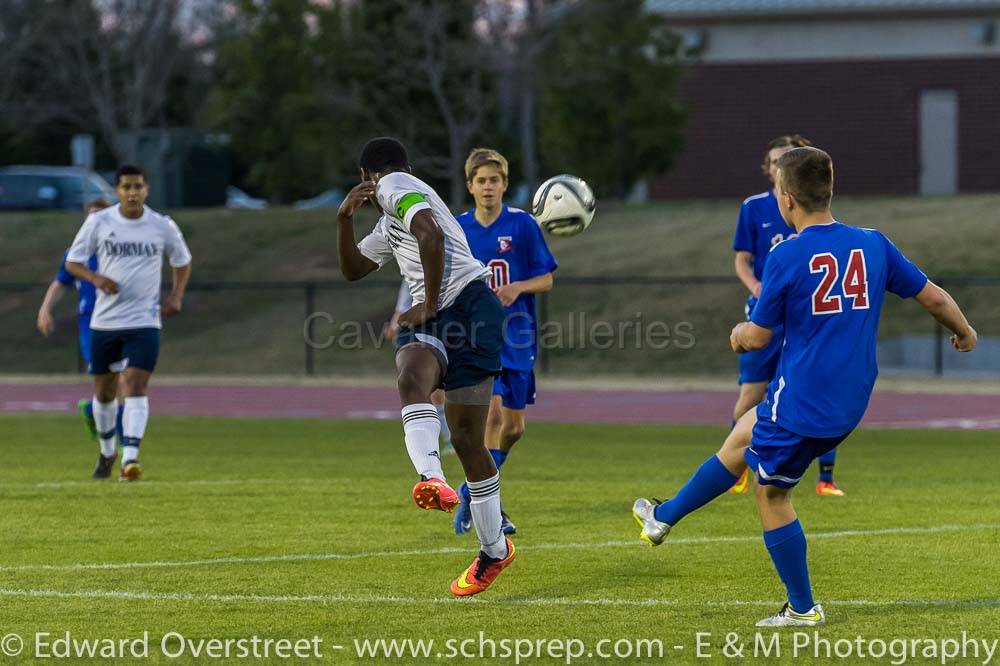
648,0,1000,198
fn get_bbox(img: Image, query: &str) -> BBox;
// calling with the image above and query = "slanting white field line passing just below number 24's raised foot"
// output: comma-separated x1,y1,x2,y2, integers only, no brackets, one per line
0,523,1000,573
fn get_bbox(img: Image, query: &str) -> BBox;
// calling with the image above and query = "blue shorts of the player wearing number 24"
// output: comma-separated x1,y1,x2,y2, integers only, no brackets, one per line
743,414,851,488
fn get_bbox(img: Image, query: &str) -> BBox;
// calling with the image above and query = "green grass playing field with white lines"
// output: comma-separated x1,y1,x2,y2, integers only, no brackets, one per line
0,416,1000,663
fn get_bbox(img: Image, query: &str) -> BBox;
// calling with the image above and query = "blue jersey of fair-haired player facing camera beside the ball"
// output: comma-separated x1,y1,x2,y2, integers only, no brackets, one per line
458,206,557,370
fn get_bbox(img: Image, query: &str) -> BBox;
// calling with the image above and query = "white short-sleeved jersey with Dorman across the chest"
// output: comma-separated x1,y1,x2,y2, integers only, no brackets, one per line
66,201,191,331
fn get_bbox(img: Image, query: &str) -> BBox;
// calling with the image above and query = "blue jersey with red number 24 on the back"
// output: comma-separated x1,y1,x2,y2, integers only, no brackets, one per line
750,222,927,437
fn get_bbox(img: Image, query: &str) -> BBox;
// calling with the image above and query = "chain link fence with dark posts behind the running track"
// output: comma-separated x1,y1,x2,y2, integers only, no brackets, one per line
0,275,1000,377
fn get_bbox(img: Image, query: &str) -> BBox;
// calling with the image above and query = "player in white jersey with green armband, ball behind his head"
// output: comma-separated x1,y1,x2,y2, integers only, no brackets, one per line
337,137,515,596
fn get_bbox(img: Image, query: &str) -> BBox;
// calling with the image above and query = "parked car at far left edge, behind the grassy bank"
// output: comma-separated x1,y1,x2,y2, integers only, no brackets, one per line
0,166,118,210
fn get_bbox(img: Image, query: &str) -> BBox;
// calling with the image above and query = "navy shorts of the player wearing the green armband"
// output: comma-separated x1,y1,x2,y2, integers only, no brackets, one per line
396,280,504,391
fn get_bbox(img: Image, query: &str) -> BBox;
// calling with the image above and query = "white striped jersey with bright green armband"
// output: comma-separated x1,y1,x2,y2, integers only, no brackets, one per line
358,171,490,309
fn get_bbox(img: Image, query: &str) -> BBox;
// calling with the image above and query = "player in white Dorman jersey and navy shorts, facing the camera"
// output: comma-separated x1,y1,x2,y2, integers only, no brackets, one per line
66,165,191,481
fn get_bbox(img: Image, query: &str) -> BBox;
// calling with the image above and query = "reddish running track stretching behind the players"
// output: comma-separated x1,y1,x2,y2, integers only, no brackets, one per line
0,383,1000,429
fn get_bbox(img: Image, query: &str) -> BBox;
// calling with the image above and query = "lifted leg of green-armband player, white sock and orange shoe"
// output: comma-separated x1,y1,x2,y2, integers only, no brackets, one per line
396,343,458,512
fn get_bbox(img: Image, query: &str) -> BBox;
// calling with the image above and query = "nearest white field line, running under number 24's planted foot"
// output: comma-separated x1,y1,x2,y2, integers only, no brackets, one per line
0,588,1000,608
